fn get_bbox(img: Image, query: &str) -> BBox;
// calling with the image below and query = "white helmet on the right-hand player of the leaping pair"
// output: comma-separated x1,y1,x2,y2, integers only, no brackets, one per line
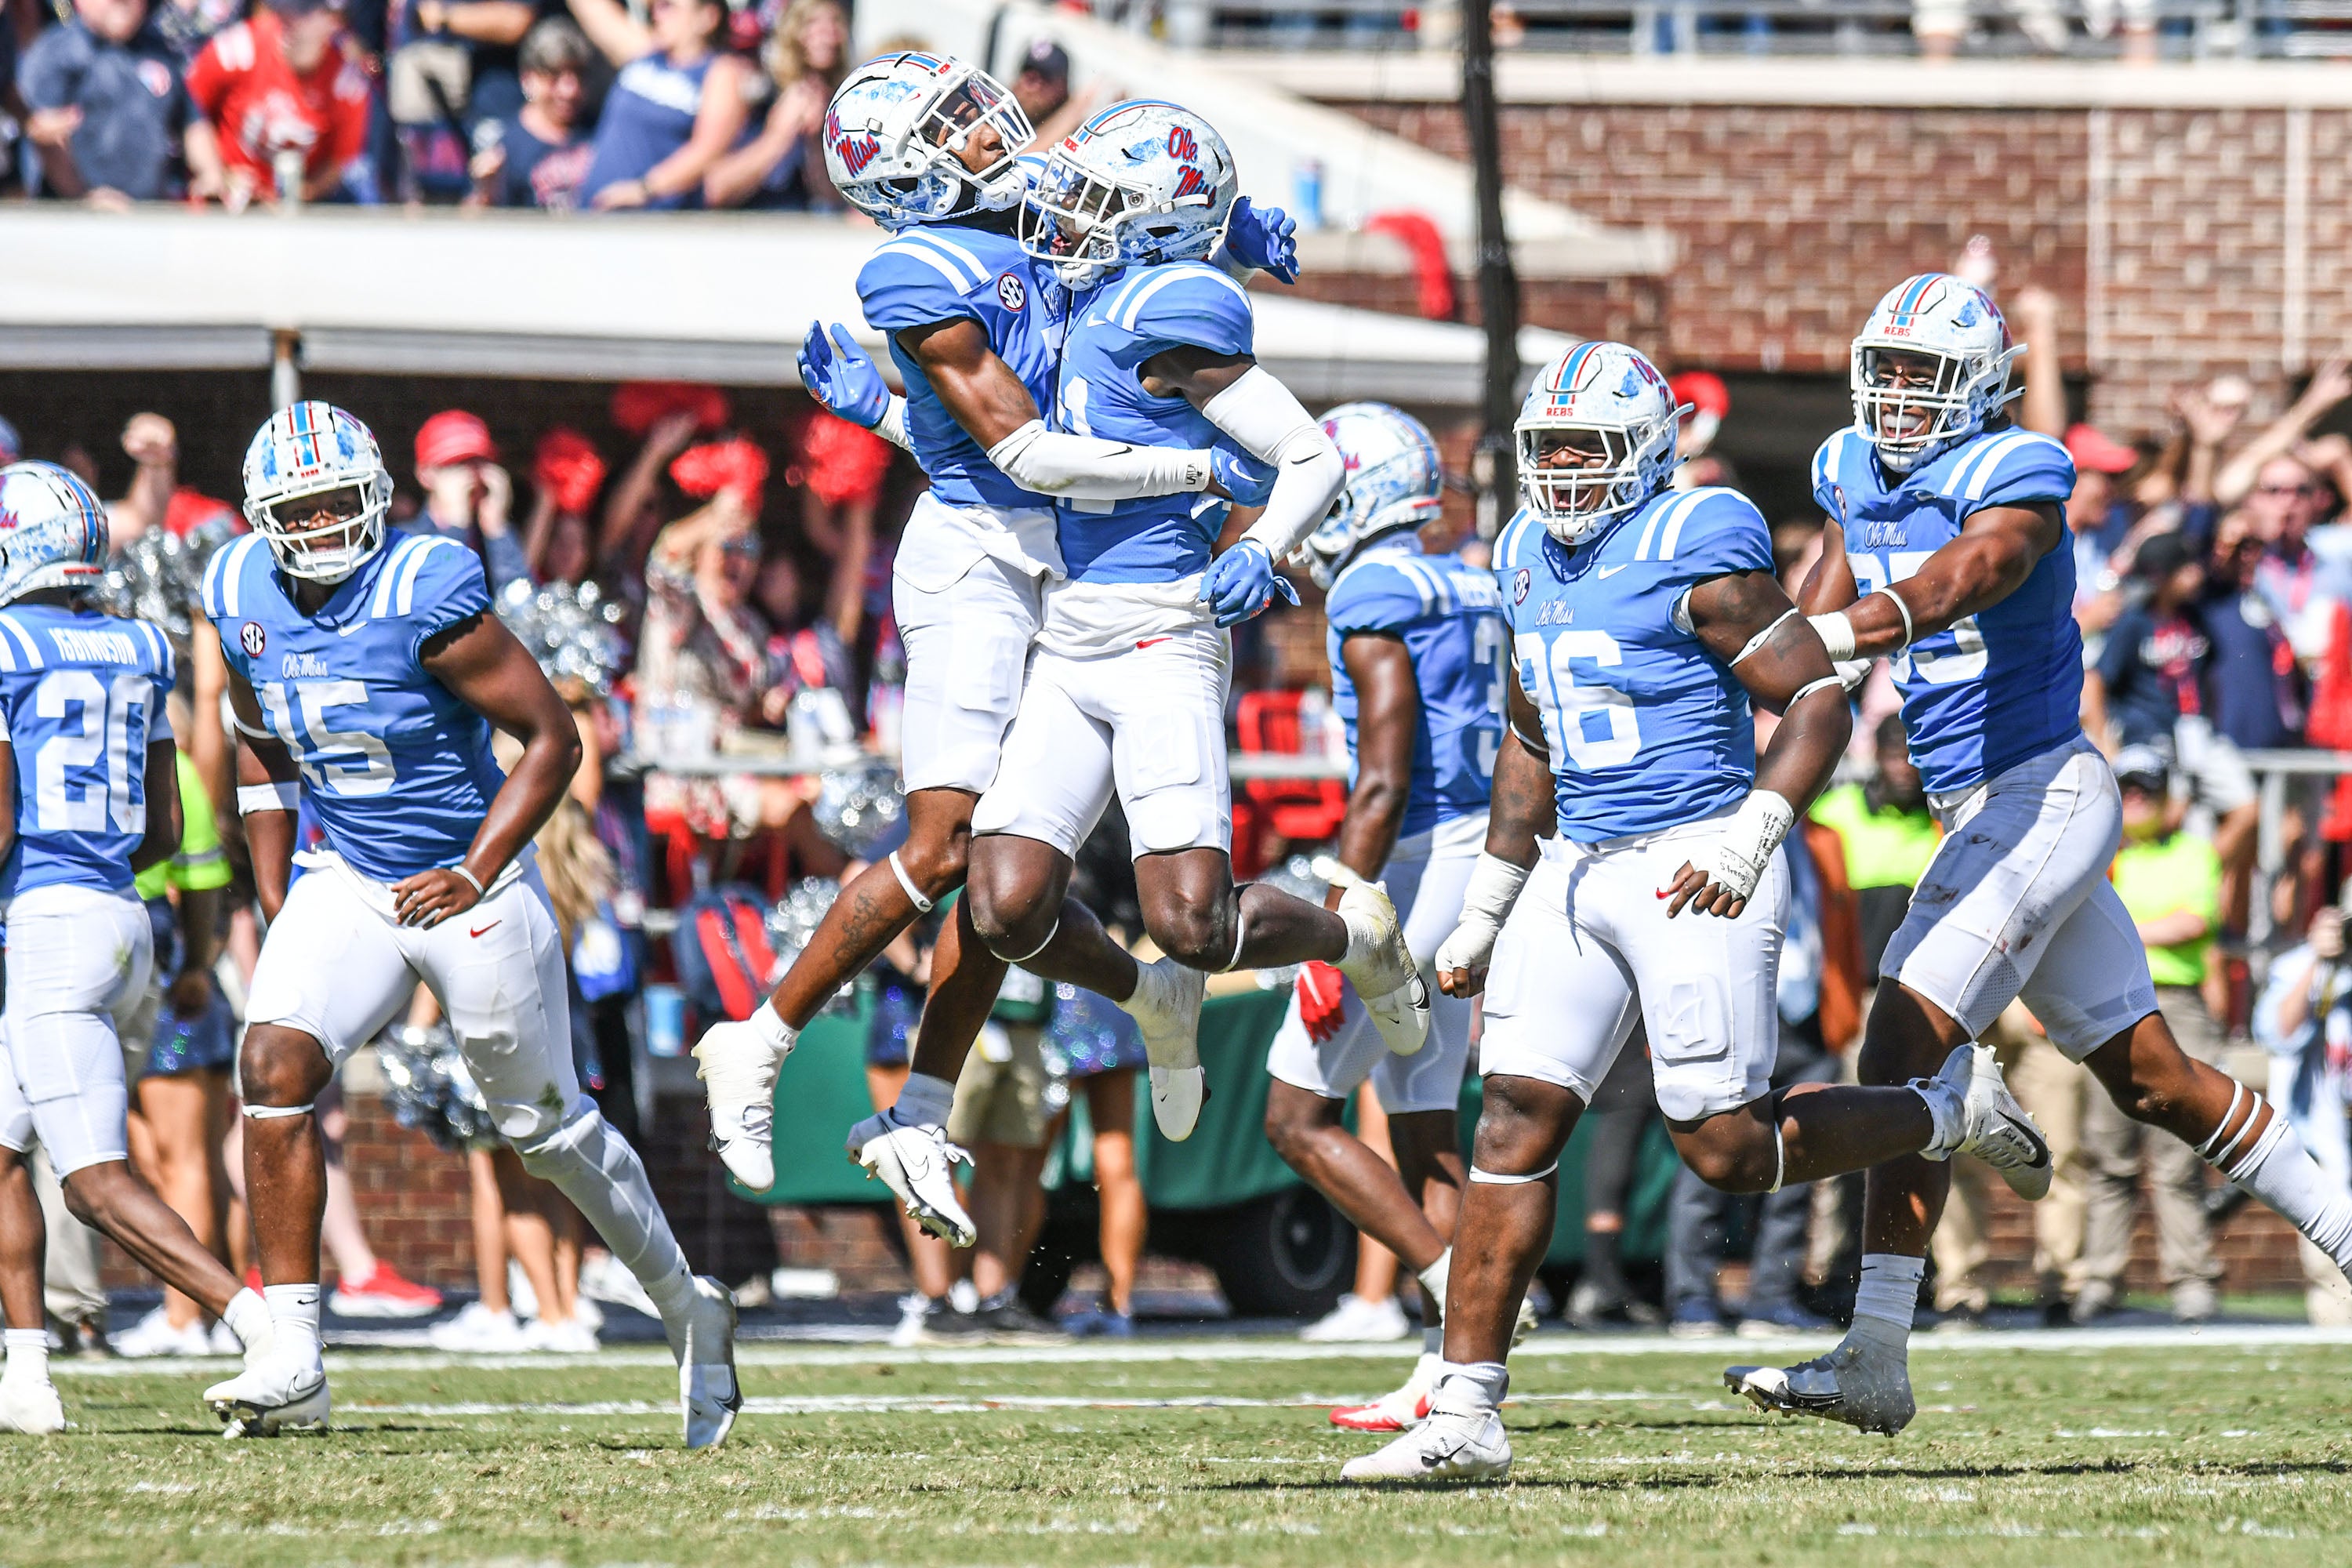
1021,99,1240,289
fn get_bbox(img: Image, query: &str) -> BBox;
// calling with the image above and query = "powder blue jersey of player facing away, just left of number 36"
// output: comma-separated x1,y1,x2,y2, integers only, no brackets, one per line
1324,529,1510,834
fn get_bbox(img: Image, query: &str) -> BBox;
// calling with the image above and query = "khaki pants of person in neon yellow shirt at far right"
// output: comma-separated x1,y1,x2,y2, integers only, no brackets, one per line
2082,985,2223,1293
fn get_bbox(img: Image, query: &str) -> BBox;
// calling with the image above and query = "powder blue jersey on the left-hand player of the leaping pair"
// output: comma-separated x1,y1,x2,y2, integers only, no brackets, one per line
858,223,1068,508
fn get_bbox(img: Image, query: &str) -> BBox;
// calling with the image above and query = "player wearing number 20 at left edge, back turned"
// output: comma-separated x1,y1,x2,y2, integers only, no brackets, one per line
0,463,270,1432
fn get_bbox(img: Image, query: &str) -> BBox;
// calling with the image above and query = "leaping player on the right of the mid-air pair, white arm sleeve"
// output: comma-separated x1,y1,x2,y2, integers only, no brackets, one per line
957,101,1428,1138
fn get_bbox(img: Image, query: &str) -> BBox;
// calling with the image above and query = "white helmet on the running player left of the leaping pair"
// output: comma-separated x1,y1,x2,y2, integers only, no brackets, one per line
245,400,393,583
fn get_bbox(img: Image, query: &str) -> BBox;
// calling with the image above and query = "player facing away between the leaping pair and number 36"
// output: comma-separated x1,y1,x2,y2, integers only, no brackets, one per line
1265,402,1510,1432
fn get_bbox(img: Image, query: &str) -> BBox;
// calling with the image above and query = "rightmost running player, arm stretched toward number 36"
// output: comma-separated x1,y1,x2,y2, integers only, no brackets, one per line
1724,273,2352,1434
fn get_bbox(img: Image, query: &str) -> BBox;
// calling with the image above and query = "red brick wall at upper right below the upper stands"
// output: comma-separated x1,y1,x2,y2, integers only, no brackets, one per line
1319,101,2352,435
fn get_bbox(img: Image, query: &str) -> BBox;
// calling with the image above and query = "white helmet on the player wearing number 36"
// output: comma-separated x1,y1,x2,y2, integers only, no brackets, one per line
1515,343,1682,546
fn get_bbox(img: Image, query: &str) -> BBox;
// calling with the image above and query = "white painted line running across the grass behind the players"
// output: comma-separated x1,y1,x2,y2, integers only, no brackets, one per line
49,1323,2352,1377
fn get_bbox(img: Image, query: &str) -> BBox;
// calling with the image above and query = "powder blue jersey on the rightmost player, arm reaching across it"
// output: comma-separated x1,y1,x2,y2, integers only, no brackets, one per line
1813,430,2082,794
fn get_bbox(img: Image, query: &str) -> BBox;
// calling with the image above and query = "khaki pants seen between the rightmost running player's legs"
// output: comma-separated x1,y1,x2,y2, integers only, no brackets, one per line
1929,1001,2105,1312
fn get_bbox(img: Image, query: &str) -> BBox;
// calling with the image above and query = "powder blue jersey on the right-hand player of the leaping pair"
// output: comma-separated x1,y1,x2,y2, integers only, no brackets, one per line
1056,261,1256,583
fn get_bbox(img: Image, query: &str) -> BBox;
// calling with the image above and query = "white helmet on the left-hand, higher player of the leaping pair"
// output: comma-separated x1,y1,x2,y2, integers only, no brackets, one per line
826,54,1037,230
